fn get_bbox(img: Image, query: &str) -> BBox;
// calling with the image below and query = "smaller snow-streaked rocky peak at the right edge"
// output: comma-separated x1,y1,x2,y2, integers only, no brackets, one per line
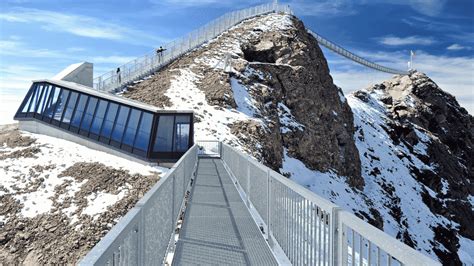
350,72,474,264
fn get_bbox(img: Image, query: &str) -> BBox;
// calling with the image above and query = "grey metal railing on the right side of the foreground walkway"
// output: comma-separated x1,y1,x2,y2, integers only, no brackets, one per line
221,144,439,265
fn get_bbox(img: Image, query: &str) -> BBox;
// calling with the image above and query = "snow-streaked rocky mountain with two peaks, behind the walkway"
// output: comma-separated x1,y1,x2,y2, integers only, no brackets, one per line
119,11,474,264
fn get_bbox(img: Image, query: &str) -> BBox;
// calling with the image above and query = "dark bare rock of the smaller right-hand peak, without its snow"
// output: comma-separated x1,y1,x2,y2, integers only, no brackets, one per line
354,72,474,264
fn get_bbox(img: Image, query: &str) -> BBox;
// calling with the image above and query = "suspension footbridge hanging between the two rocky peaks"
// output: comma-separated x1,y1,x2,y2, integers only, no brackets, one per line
308,30,408,75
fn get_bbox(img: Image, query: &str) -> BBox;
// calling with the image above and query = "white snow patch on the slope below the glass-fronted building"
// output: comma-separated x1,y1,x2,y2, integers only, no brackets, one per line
0,132,167,218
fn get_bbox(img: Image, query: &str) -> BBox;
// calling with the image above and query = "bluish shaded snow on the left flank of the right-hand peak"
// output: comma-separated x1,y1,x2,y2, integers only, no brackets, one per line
347,94,453,259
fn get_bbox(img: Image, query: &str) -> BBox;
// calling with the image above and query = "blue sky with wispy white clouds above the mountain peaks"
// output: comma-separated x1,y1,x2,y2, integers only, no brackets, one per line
0,0,474,116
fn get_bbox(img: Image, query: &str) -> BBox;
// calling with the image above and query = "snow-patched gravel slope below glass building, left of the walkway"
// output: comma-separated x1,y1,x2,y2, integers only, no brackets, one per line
0,125,167,265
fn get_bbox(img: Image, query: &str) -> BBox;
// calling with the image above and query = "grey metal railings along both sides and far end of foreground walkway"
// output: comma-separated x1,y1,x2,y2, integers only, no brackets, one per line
80,142,440,266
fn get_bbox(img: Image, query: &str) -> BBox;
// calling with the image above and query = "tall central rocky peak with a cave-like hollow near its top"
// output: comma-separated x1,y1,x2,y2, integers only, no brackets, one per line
123,14,364,189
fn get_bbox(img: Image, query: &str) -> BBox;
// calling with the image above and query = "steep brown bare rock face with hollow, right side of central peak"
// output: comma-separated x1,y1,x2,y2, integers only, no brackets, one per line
242,18,364,189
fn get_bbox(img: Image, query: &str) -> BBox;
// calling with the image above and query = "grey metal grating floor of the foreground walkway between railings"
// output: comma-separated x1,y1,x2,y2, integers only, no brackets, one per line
173,158,277,265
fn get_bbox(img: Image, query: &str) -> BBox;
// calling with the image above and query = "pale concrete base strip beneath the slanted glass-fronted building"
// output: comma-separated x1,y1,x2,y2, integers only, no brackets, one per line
18,120,162,168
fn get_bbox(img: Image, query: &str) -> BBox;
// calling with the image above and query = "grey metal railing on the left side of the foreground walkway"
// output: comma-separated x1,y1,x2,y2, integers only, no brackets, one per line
79,145,198,265
